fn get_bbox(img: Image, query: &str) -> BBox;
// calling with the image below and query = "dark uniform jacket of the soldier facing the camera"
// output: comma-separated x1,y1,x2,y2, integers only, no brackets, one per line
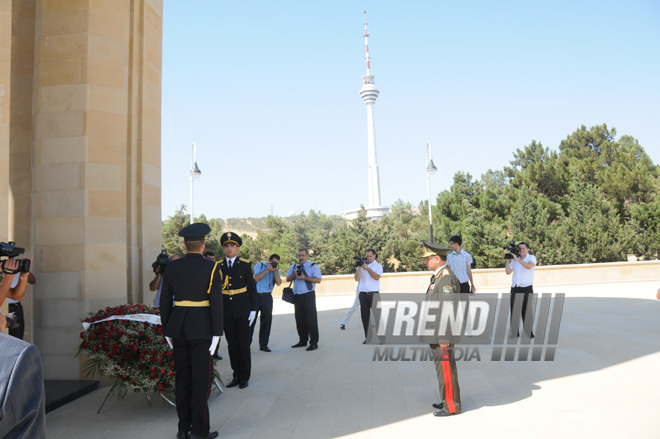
218,258,257,319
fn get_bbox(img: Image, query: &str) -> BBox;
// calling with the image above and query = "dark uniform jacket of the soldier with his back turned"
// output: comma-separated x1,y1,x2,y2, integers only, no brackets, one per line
160,253,223,340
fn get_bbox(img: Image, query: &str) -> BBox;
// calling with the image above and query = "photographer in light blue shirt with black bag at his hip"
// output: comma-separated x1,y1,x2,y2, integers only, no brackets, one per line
286,248,321,351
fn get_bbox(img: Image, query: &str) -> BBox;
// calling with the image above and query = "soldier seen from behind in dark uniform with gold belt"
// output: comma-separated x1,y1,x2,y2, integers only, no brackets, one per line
160,223,223,439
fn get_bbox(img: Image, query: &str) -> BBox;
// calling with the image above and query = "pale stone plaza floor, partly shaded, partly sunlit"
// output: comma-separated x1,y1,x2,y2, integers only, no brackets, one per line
47,280,660,439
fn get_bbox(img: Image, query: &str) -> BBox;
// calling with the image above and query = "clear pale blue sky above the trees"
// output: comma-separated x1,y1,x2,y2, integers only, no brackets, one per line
161,0,660,218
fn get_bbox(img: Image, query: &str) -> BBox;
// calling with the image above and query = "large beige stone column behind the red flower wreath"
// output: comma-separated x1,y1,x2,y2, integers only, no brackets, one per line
21,0,162,379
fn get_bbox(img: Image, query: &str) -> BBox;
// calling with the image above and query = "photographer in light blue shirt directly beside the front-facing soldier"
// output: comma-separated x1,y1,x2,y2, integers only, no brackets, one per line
250,254,282,352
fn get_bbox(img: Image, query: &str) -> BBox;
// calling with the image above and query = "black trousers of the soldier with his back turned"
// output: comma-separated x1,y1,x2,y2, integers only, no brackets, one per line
174,338,213,436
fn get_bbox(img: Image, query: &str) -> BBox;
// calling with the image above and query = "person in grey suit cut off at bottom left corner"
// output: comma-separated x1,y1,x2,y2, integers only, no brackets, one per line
0,324,46,438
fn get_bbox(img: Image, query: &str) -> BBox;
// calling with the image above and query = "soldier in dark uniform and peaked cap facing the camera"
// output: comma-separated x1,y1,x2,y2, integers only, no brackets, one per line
219,232,257,389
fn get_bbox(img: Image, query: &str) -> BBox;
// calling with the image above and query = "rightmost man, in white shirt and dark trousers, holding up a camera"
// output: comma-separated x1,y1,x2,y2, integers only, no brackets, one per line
504,241,536,338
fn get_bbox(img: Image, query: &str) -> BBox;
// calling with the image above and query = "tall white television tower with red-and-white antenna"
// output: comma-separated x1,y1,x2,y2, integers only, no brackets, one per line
360,9,389,218
